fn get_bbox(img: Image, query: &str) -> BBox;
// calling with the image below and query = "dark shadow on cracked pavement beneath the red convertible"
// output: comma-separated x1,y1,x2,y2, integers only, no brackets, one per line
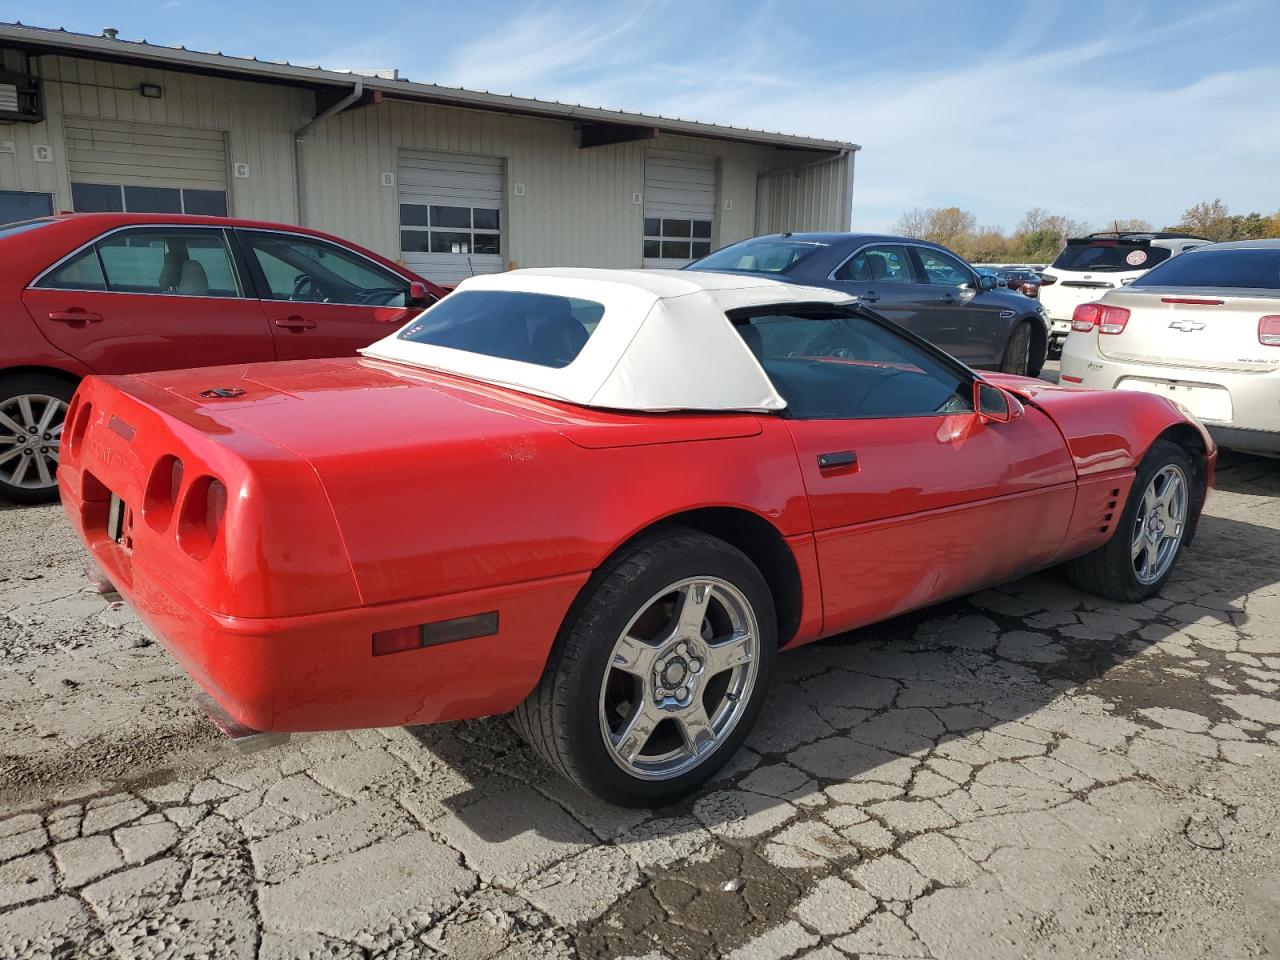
412,506,1280,852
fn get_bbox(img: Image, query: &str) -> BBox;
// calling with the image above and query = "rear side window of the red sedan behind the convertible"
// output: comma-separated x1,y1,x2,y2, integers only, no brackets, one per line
95,227,243,297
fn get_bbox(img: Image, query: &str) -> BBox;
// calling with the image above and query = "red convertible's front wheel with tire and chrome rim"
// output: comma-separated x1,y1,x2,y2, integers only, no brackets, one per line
1062,440,1203,603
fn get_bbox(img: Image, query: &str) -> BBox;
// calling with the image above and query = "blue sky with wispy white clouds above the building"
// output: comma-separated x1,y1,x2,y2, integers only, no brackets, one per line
12,0,1280,229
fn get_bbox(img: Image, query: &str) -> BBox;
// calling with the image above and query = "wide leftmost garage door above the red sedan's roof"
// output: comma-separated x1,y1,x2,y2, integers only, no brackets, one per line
63,116,228,216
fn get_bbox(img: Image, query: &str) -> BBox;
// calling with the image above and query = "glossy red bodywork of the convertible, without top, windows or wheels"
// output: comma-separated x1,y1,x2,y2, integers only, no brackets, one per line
58,358,1213,731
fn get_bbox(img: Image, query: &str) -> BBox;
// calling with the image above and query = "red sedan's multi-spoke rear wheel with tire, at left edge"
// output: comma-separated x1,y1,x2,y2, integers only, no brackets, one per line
0,374,76,503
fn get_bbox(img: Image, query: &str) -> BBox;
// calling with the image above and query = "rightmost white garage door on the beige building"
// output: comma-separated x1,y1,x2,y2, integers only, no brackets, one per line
644,150,716,266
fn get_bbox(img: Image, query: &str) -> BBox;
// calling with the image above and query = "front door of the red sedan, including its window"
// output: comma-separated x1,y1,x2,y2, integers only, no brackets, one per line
237,229,421,360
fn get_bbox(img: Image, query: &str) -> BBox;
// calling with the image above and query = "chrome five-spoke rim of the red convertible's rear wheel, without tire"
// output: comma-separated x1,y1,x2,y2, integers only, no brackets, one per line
599,577,760,780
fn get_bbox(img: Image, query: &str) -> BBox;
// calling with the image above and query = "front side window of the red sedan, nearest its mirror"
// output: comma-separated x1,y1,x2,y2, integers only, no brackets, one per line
241,230,408,307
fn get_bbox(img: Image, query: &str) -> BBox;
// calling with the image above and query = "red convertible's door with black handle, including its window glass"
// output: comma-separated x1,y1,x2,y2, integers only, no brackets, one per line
735,307,1075,634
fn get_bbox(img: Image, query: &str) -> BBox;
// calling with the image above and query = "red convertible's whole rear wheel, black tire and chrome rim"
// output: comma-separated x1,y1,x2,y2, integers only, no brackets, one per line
515,527,777,806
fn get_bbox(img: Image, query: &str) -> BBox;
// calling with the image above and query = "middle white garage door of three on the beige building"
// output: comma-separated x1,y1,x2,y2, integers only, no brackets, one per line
398,152,506,283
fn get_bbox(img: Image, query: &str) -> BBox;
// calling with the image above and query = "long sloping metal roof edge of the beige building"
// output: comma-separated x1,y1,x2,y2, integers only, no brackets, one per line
0,22,860,152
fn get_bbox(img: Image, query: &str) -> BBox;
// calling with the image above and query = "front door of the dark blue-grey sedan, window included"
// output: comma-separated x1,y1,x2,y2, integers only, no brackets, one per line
911,246,1012,366
